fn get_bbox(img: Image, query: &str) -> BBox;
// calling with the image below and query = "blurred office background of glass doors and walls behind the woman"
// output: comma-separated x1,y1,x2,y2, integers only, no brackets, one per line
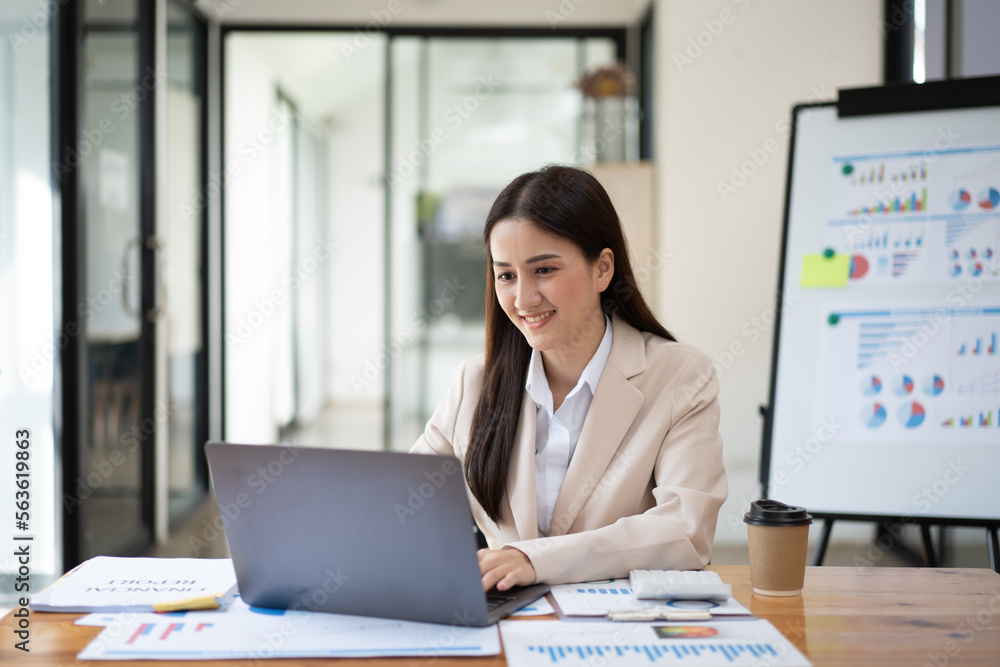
0,0,1000,596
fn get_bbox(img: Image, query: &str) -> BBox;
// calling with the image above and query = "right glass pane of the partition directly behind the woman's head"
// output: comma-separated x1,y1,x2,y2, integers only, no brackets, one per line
385,37,618,450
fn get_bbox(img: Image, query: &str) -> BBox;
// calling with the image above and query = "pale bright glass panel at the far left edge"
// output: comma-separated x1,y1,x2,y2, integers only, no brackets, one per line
0,0,58,584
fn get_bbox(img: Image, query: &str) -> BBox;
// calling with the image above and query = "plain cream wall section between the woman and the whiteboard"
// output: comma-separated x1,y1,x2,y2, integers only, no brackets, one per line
655,0,883,544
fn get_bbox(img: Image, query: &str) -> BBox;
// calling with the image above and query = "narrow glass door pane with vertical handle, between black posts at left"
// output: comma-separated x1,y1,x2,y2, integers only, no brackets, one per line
76,0,152,565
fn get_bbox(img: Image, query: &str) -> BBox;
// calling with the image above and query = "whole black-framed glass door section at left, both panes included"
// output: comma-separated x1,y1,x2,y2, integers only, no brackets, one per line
71,0,210,565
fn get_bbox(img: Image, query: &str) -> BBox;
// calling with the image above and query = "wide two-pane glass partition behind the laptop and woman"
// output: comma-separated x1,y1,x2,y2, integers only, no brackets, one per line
223,28,624,450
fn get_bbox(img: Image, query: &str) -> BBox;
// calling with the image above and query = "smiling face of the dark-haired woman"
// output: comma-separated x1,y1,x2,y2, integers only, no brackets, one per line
490,218,614,366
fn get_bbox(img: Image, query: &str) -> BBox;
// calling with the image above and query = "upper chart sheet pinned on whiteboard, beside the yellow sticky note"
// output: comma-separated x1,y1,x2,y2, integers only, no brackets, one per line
825,146,1000,288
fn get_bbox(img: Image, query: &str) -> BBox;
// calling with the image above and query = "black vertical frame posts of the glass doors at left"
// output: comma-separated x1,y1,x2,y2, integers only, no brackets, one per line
56,0,214,571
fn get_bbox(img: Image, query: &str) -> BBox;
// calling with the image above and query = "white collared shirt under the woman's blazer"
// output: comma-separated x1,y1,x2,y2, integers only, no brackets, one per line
525,316,612,537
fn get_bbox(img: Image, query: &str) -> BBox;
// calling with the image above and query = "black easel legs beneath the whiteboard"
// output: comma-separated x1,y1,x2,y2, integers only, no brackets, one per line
812,512,1000,573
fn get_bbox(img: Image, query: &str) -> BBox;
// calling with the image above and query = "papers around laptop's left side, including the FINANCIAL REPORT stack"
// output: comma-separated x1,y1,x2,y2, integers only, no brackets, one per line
31,556,504,660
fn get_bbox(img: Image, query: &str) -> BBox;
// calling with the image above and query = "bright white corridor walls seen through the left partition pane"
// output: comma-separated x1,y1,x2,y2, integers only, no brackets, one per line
223,33,385,442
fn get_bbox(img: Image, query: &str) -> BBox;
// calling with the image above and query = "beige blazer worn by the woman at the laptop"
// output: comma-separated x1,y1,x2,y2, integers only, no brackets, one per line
411,317,728,584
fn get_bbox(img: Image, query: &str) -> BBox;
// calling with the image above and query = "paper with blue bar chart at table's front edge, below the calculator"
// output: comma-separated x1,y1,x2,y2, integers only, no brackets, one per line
500,620,810,667
